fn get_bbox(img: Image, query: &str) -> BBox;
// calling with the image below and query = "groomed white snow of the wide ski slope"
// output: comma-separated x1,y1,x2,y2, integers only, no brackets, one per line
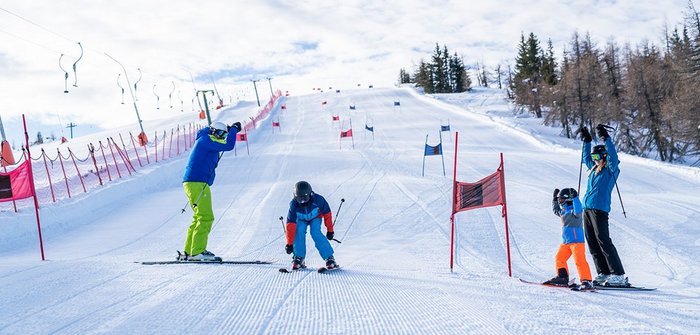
0,88,700,335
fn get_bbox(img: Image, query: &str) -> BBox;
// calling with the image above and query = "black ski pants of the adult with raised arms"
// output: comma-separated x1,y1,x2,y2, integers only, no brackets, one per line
583,209,625,275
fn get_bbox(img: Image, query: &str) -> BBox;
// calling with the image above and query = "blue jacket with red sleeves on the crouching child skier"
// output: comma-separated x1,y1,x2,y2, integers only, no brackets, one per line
287,193,333,244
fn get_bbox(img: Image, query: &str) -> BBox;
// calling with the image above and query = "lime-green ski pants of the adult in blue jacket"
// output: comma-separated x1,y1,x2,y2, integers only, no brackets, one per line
182,182,214,255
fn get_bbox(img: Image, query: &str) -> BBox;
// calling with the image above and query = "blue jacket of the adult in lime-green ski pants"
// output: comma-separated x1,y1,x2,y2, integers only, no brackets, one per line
182,127,238,186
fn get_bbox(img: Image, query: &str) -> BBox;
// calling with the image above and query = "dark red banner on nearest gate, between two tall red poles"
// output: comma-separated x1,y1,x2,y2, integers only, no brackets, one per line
452,169,505,213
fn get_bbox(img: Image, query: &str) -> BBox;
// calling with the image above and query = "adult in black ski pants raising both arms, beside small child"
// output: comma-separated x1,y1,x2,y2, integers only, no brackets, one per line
581,124,629,286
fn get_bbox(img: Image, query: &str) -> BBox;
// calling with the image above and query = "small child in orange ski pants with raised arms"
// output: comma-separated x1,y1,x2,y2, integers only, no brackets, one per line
544,188,593,290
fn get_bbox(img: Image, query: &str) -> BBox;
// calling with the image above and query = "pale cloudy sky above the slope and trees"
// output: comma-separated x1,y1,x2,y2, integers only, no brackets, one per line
0,0,687,146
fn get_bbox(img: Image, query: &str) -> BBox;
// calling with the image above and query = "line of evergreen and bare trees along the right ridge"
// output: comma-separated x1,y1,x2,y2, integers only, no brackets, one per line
400,2,700,165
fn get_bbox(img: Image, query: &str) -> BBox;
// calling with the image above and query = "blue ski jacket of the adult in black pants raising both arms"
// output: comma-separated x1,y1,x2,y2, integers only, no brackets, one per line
582,138,620,213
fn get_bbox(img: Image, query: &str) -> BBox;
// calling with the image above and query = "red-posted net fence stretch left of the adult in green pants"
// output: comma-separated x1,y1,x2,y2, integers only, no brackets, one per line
0,123,202,211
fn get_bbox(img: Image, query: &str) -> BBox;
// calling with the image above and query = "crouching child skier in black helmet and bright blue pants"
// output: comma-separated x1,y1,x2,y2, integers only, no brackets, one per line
284,181,338,270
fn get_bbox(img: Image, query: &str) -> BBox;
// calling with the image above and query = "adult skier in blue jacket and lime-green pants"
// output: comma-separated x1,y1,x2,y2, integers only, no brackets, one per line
181,121,241,261
